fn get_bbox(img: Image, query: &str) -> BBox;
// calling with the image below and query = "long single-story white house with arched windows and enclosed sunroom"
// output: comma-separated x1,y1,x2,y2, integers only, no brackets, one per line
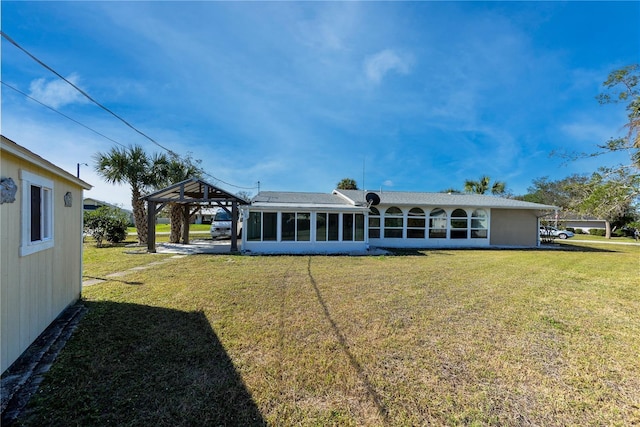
241,190,558,253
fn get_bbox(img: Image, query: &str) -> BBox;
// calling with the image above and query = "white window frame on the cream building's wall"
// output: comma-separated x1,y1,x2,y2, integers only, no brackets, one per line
20,170,54,256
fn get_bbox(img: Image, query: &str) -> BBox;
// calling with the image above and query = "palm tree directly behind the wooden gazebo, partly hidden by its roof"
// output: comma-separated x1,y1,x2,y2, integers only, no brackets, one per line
154,155,203,243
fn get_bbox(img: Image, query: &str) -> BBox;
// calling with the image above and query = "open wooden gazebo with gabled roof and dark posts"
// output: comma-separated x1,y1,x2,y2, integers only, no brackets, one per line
144,178,249,253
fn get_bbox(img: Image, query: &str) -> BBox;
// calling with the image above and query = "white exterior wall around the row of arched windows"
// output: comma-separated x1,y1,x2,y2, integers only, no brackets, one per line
367,205,491,249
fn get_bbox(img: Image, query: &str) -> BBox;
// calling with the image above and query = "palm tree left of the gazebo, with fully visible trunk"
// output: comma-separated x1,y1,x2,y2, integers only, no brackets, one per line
94,145,155,244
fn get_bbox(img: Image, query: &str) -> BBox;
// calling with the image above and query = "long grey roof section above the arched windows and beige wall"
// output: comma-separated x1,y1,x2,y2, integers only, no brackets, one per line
333,190,558,210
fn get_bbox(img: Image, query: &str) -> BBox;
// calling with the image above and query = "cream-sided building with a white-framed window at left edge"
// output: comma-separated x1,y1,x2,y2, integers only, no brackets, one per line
0,136,91,372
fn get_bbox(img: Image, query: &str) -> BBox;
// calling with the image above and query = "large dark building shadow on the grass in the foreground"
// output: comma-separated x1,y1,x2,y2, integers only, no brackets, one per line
19,302,266,426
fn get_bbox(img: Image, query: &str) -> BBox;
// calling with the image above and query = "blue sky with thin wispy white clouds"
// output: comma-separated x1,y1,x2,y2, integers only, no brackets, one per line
1,1,640,207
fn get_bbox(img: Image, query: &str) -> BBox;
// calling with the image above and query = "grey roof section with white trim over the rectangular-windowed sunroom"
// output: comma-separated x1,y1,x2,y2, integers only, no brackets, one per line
251,191,366,211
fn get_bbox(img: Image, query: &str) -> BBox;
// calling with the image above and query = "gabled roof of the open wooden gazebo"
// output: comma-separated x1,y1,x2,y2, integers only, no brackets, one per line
144,178,249,206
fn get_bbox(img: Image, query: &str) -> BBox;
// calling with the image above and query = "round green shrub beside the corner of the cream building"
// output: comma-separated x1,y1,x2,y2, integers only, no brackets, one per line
84,206,129,248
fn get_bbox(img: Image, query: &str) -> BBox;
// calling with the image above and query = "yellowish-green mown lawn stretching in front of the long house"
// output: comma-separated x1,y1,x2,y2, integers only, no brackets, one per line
20,240,640,426
